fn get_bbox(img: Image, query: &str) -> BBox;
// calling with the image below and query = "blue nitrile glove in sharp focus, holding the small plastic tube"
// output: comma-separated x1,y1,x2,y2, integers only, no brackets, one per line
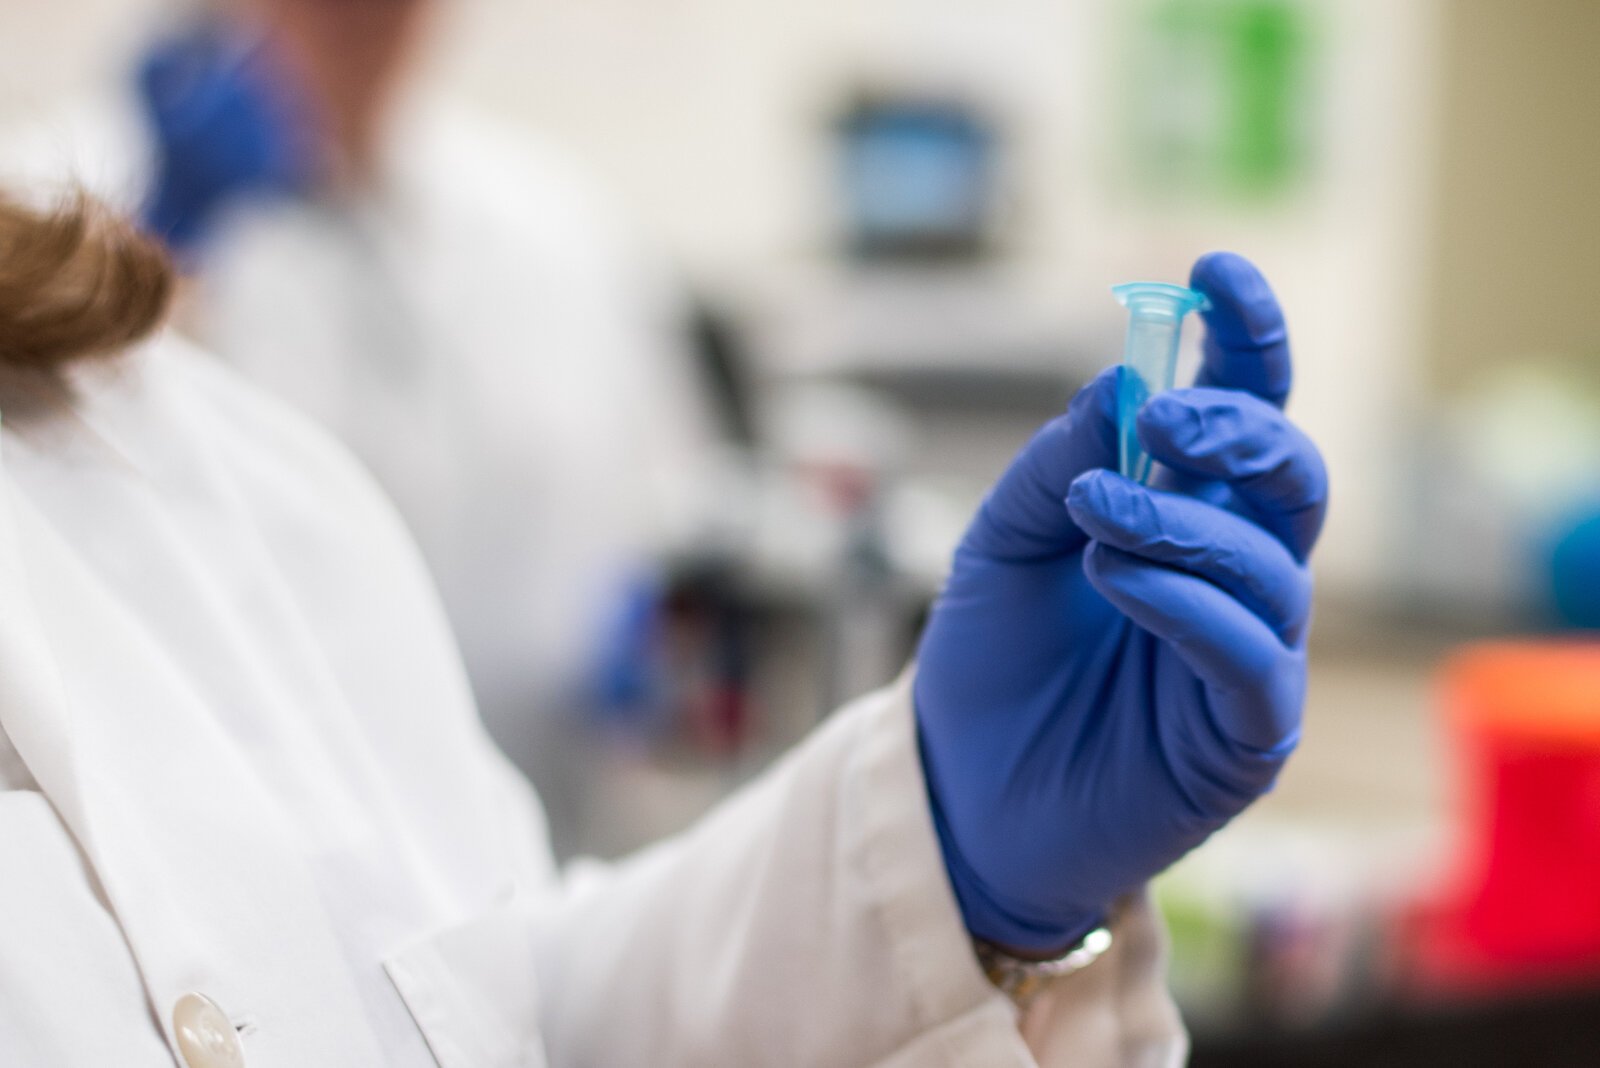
915,253,1328,953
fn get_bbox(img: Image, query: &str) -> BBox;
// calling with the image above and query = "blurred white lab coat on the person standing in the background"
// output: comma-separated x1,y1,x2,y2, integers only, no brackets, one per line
3,99,717,759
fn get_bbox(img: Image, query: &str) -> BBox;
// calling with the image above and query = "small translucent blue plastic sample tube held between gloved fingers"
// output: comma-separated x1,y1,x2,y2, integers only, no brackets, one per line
1110,281,1211,483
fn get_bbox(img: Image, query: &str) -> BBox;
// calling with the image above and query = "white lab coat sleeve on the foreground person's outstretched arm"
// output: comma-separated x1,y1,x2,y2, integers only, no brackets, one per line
534,679,1184,1068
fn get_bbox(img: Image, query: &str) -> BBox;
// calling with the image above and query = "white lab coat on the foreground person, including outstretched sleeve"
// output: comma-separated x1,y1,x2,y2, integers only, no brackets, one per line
0,342,1182,1068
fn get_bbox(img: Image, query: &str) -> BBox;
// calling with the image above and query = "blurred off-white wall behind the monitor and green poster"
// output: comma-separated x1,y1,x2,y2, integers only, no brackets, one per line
0,0,1438,593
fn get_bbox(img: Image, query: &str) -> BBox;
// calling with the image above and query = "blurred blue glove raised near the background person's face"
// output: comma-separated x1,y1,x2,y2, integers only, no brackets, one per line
139,22,315,256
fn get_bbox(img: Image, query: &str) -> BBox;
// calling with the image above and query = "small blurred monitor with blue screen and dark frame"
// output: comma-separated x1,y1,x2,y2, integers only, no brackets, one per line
838,96,997,261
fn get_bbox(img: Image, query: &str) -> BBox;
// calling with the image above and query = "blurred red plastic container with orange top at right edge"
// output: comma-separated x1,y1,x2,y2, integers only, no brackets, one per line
1416,643,1600,991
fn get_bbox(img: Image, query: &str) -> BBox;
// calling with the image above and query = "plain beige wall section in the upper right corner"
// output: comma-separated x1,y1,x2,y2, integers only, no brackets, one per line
1427,0,1600,389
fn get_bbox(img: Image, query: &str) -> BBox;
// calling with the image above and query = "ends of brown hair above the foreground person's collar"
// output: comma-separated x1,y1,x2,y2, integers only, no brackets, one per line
0,193,174,369
